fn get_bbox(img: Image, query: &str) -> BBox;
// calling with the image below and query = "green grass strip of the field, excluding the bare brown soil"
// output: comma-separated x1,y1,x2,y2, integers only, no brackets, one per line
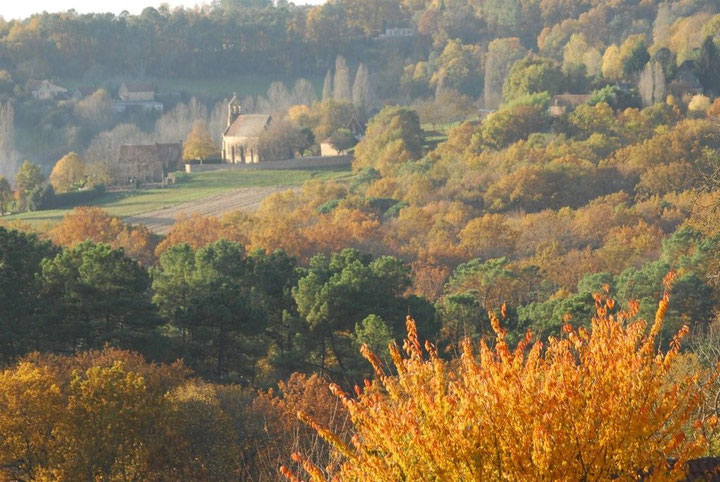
3,169,352,225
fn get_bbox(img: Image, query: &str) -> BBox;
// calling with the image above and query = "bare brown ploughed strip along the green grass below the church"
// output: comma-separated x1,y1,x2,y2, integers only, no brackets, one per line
123,186,299,234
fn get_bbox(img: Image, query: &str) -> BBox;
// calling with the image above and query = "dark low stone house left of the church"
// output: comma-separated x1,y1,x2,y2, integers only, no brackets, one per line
119,142,183,182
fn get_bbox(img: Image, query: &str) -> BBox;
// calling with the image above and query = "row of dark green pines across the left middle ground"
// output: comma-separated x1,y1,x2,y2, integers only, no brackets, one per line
0,224,435,384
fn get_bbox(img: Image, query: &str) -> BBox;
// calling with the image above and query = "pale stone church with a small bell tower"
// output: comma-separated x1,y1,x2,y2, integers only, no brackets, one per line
222,94,272,164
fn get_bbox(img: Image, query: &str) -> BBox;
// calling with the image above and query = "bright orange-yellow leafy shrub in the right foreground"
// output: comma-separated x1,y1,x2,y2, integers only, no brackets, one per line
282,275,707,481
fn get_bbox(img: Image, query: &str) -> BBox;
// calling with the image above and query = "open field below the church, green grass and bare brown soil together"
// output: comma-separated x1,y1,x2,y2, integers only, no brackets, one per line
4,169,351,233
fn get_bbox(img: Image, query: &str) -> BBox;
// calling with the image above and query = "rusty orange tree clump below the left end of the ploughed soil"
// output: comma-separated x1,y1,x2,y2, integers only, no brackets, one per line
50,206,157,265
